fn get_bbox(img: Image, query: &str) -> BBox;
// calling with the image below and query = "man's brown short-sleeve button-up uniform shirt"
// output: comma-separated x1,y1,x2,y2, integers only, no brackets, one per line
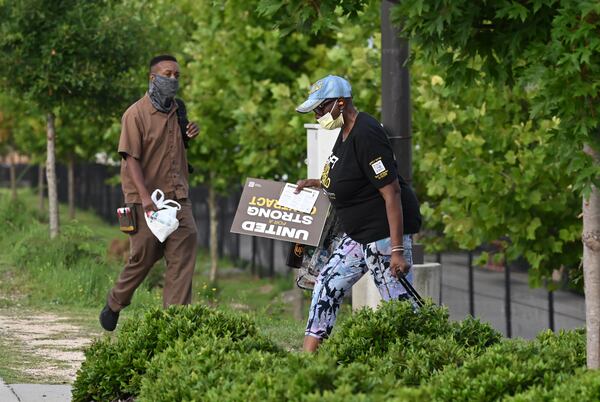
119,94,189,203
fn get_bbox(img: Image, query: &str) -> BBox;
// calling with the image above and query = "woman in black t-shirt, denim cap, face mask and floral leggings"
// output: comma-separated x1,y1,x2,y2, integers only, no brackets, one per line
296,75,421,352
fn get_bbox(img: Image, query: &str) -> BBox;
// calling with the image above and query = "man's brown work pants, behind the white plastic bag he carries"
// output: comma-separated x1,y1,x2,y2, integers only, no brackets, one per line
108,199,197,311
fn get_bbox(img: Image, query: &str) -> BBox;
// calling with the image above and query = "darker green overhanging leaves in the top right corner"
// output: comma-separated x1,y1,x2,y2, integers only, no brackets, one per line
394,0,600,192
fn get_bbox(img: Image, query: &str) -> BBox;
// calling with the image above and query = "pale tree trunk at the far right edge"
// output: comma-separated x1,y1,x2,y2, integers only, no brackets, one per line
582,145,600,369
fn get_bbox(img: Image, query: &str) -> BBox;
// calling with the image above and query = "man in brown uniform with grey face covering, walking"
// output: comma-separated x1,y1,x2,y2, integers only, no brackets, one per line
100,55,199,331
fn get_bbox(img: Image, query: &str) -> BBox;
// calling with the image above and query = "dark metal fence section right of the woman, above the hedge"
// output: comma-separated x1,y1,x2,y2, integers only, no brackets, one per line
432,252,585,338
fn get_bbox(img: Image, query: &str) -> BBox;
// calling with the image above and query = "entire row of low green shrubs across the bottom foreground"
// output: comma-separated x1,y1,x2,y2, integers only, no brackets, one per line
73,302,588,402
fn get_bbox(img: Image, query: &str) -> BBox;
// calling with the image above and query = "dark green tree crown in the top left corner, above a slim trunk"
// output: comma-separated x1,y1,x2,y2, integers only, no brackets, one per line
0,0,149,113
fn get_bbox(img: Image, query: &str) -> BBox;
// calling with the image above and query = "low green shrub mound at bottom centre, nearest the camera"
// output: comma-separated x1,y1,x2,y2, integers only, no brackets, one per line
137,338,423,402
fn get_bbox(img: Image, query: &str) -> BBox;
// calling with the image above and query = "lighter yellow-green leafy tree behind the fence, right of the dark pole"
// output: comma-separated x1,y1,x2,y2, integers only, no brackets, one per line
413,63,581,285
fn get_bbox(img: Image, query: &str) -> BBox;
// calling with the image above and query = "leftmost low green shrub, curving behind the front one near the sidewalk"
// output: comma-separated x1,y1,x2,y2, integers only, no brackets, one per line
72,305,262,402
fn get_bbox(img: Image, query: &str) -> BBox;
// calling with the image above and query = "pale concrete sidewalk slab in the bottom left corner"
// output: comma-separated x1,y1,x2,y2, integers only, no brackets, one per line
0,378,71,402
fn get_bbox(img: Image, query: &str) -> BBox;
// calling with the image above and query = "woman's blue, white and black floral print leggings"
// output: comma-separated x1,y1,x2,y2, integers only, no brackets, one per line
305,235,412,339
